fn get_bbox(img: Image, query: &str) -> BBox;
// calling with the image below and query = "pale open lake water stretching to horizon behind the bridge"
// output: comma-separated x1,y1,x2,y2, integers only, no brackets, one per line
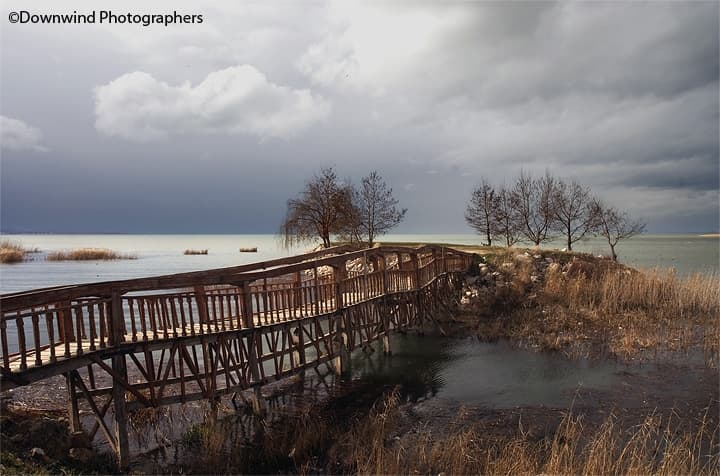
0,234,720,293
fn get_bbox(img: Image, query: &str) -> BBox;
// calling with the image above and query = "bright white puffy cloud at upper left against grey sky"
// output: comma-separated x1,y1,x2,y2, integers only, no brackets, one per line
95,65,331,141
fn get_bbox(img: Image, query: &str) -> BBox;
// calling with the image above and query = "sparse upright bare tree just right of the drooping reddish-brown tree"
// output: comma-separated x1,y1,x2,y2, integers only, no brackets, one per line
354,171,407,246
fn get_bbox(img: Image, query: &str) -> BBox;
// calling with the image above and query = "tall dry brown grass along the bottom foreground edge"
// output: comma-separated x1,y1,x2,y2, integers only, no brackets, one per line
177,392,720,475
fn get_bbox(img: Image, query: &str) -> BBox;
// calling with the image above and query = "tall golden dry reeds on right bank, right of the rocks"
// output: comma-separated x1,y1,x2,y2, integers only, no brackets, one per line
539,269,720,364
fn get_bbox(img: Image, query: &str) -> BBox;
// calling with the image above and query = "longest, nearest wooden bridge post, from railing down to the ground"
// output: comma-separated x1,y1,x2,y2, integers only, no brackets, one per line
110,292,130,469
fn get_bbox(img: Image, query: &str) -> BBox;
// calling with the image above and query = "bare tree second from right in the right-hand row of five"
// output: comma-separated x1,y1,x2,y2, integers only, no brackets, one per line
550,179,596,251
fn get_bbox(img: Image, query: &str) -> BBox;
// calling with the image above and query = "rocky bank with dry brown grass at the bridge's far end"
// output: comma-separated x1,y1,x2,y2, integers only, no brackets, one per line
455,249,720,366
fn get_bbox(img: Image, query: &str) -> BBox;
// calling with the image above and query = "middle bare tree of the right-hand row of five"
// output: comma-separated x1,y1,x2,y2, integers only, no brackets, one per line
512,172,555,246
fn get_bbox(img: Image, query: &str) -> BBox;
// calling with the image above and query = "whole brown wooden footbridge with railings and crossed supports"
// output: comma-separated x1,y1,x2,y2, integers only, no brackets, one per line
0,246,471,467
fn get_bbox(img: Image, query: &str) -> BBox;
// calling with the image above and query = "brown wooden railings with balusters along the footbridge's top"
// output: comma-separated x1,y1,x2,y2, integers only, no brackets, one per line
0,246,471,380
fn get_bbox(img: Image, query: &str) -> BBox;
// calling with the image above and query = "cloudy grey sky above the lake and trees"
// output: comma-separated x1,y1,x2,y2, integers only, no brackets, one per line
0,0,720,233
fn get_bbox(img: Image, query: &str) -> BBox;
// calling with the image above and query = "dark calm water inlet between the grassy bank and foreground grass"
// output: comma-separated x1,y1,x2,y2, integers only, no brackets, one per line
352,334,718,408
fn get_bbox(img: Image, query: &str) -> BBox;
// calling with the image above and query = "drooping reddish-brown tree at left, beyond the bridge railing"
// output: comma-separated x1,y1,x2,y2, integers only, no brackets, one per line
280,167,351,248
